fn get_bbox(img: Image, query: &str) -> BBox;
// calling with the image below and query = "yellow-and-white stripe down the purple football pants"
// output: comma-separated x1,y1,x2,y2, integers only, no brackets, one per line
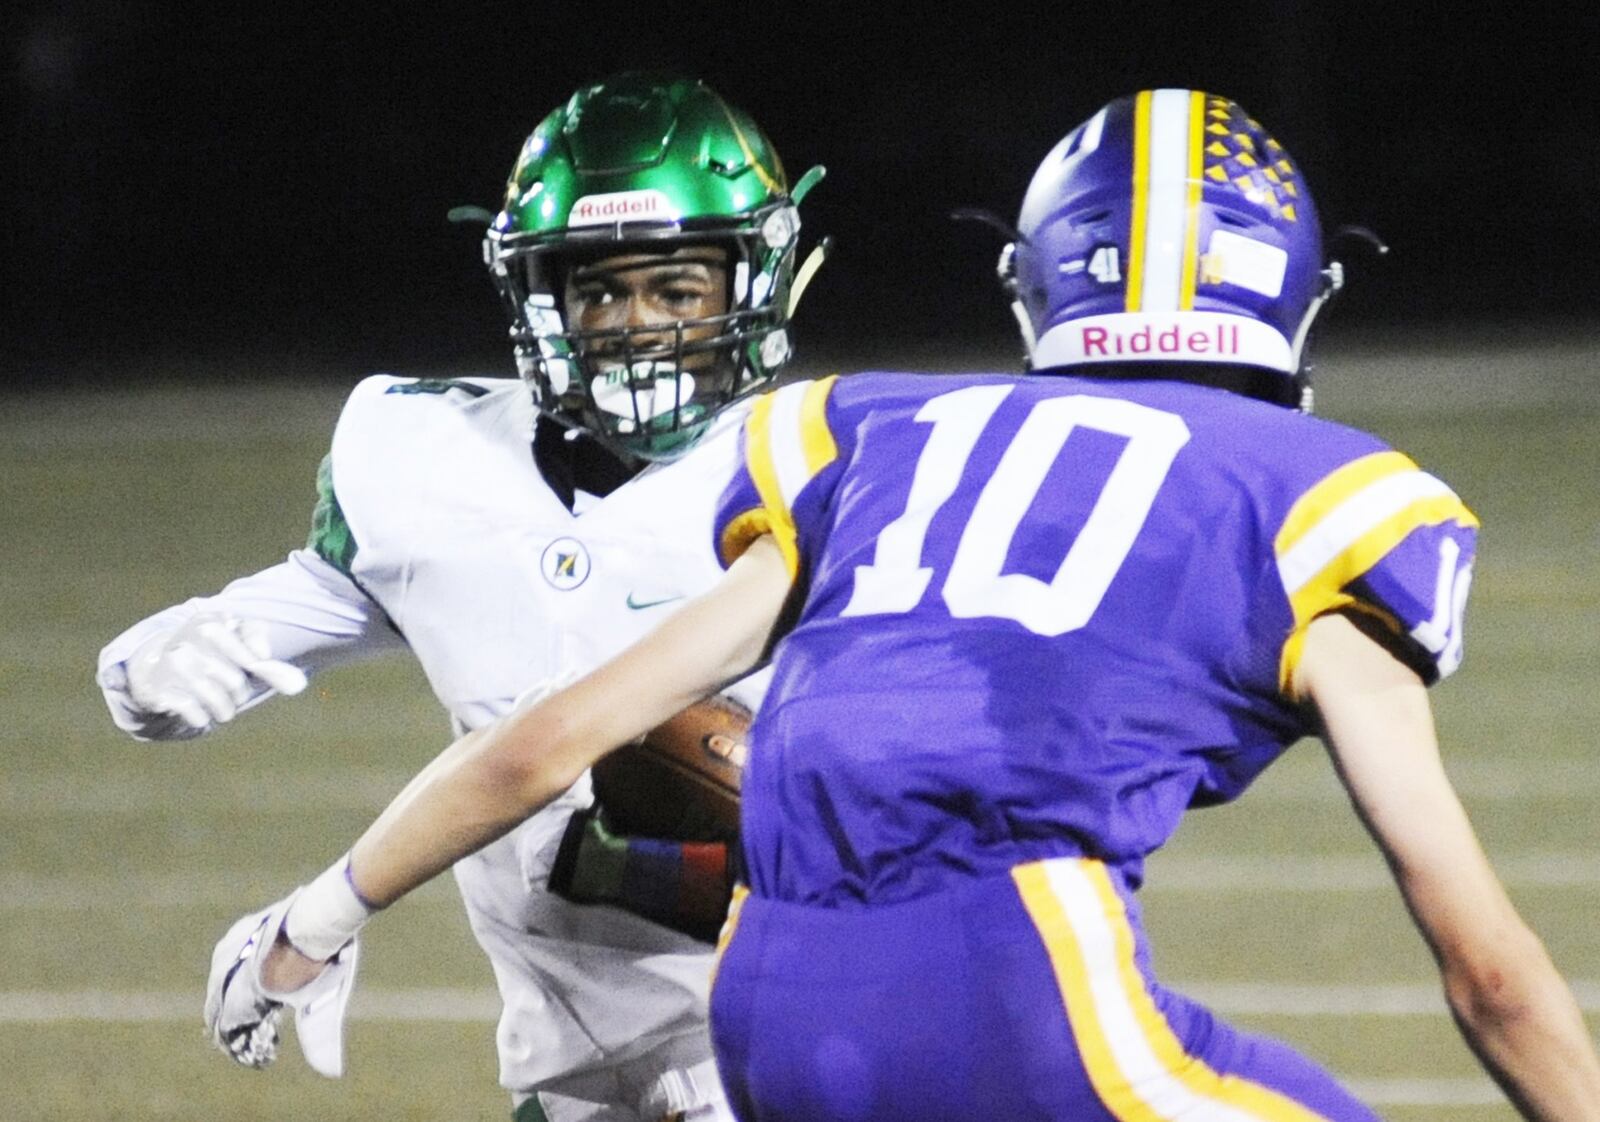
1011,858,1323,1122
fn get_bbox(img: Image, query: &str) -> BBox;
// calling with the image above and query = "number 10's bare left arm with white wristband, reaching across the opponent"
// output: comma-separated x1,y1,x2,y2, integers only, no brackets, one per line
228,536,790,992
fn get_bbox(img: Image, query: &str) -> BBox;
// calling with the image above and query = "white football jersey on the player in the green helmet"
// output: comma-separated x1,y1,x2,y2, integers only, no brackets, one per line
99,376,758,1092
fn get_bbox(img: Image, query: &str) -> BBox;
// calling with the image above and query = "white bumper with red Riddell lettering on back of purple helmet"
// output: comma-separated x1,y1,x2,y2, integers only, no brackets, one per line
1034,312,1293,371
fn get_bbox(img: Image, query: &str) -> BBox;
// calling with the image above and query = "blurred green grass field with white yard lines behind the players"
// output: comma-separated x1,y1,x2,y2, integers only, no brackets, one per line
0,341,1600,1122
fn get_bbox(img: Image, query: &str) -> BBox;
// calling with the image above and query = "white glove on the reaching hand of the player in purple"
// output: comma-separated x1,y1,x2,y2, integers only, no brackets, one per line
205,888,360,1079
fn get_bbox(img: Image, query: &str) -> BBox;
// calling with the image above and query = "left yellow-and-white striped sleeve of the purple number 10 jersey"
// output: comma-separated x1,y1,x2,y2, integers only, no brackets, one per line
712,378,838,578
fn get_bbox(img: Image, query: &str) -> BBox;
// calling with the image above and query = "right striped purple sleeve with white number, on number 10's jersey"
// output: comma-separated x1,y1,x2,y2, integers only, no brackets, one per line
1274,451,1478,683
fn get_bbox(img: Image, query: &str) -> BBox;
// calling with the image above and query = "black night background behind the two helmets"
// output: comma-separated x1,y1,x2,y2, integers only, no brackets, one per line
0,0,1600,387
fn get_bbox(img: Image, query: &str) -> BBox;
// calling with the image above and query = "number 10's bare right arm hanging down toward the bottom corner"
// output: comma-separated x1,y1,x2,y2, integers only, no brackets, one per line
1294,616,1600,1122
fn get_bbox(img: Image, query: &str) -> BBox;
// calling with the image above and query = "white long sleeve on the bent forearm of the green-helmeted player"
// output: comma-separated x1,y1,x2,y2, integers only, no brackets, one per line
94,549,405,739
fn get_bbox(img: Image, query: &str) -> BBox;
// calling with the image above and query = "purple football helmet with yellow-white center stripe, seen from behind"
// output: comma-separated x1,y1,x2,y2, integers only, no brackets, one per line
1002,90,1339,408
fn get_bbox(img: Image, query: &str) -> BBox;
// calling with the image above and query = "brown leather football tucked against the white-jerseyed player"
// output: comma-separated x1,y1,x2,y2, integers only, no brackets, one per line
594,696,750,842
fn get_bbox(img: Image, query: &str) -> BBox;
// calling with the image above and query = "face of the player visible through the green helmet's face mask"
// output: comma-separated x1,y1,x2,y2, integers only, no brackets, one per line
565,245,728,368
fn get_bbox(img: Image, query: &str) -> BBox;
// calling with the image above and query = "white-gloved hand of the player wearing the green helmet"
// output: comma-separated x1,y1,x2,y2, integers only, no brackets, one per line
128,611,306,730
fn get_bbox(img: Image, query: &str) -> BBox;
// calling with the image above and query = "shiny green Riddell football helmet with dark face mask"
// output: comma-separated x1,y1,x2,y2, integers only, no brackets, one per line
483,72,826,459
